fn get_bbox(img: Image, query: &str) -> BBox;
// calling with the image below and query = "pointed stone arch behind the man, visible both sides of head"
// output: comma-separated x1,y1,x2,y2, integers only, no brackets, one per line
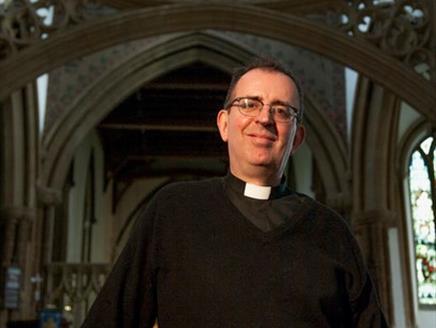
42,33,347,205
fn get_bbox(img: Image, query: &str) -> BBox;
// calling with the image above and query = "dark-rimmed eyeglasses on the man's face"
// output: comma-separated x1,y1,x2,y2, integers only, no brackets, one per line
227,97,298,123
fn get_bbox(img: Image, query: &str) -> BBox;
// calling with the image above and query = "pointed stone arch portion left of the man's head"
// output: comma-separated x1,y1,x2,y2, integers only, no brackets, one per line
43,34,252,189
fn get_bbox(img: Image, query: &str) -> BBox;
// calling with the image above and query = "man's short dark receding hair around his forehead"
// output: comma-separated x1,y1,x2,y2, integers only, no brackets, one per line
224,57,304,123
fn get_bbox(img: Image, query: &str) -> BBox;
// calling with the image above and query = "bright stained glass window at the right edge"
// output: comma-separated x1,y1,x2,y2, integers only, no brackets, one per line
409,136,436,305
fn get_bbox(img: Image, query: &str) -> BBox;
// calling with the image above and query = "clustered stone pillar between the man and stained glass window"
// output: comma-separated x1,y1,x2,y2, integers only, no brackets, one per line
351,77,400,323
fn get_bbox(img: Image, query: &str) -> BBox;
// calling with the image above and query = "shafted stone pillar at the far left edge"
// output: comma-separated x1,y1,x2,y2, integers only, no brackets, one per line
0,83,39,327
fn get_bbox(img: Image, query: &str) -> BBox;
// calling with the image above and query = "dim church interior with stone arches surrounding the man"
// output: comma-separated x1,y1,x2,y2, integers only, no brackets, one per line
0,0,436,328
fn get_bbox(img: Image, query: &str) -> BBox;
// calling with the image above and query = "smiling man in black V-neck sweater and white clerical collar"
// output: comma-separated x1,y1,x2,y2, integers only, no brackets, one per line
84,60,386,328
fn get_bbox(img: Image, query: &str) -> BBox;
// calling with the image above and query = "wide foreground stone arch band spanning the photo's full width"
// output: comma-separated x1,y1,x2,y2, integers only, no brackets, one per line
0,4,436,121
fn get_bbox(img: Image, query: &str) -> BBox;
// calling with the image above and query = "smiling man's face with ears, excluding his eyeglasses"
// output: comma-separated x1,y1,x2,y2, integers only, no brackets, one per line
217,69,304,185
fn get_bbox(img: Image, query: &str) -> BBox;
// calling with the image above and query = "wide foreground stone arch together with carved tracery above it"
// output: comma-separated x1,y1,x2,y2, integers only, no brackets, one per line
0,0,436,121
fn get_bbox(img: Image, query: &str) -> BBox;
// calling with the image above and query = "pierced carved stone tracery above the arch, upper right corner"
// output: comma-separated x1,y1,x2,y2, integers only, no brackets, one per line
328,0,436,81
